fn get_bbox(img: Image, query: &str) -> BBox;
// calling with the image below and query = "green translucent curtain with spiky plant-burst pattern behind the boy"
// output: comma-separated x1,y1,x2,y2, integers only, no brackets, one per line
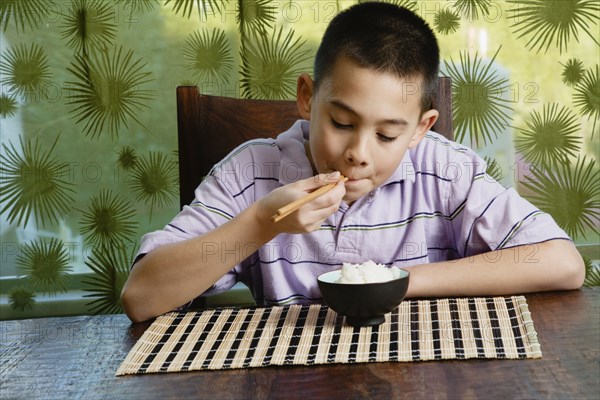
0,0,600,313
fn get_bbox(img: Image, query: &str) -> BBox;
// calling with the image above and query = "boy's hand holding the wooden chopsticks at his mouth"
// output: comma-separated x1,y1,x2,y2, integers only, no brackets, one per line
256,172,346,234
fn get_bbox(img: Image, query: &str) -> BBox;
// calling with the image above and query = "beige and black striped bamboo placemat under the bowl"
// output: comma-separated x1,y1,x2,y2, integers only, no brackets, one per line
117,296,542,375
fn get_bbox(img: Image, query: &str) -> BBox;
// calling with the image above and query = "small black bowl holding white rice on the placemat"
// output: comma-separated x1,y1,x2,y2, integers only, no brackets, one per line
317,269,410,326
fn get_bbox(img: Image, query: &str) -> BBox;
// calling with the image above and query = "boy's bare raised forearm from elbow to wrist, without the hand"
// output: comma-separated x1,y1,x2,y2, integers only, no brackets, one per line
121,203,275,322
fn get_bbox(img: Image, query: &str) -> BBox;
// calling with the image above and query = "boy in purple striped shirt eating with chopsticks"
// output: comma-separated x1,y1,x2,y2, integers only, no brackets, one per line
122,3,585,321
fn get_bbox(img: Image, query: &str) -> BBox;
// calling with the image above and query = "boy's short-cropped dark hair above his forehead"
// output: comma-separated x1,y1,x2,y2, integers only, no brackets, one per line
314,2,440,112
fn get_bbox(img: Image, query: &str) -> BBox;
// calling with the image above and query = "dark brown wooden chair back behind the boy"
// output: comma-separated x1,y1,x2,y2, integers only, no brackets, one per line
177,77,453,207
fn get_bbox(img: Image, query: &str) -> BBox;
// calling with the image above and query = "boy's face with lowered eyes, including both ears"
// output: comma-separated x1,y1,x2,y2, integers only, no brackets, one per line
298,58,438,203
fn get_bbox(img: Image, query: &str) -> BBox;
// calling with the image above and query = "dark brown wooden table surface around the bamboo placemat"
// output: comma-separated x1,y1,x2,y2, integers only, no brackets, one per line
0,288,600,400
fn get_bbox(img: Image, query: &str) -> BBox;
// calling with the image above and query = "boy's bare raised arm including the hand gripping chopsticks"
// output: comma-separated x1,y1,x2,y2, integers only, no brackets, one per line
121,175,345,322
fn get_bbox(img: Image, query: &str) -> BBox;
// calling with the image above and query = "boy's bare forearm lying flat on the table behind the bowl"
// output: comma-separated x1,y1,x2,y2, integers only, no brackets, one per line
407,239,585,297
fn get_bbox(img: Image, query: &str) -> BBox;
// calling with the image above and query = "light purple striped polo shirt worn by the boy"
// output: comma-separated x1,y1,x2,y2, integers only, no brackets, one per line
139,121,570,304
